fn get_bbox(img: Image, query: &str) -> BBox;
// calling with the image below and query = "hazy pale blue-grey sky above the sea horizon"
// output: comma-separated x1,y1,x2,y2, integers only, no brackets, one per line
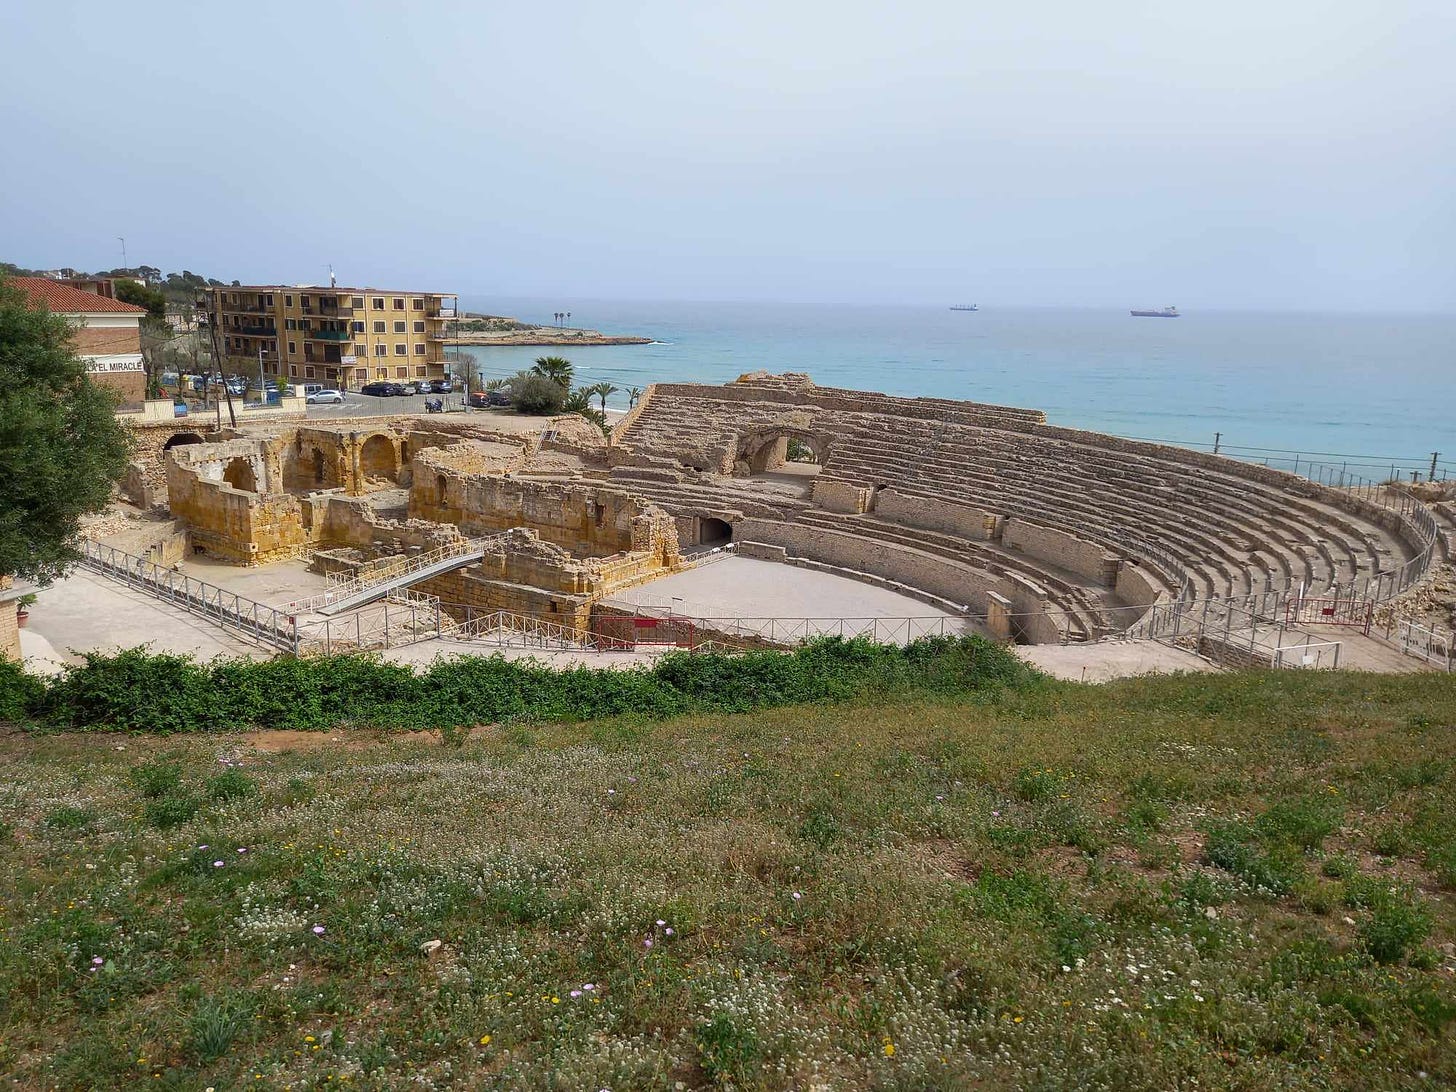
0,0,1456,310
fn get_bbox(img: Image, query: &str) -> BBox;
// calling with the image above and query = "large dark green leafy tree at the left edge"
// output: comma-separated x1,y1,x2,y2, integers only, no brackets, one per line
0,280,131,582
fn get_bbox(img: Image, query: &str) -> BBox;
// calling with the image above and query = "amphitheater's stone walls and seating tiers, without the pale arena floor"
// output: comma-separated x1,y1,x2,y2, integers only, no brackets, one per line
147,373,1444,644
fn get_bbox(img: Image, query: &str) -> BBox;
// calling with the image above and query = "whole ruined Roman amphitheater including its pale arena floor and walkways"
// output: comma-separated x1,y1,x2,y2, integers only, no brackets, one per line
39,373,1456,665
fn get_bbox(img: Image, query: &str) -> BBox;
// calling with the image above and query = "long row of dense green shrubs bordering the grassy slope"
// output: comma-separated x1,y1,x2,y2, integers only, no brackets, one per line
0,636,1038,734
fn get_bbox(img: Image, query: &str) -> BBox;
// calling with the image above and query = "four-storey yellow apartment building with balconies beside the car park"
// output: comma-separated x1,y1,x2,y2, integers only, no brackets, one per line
208,284,459,390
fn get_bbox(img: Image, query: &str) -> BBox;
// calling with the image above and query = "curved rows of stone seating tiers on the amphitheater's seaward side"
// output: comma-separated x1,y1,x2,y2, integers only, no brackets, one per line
616,376,1415,631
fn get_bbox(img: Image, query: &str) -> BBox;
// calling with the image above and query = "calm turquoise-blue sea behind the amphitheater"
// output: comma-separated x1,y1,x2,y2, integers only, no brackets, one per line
448,296,1456,478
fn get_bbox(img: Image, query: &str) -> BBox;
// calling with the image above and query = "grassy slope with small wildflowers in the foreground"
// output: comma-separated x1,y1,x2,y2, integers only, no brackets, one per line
0,671,1456,1091
